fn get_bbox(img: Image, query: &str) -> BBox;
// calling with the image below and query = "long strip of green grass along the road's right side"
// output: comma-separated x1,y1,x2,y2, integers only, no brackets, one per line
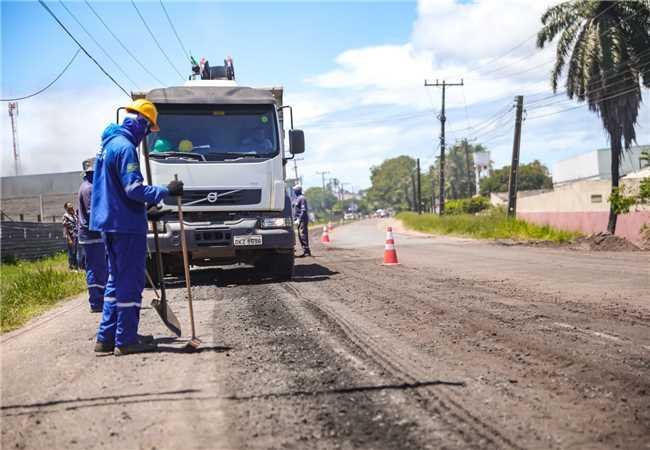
397,210,580,242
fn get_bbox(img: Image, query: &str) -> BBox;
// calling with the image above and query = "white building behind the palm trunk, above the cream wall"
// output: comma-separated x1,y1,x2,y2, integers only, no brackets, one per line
553,145,650,186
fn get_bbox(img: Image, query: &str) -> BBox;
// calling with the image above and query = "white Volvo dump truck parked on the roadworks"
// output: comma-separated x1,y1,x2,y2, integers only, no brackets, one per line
135,61,305,280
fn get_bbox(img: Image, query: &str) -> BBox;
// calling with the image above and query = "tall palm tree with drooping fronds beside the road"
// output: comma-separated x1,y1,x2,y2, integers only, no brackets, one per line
537,0,650,233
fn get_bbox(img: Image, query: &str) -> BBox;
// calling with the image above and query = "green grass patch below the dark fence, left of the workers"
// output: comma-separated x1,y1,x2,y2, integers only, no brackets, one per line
0,254,86,333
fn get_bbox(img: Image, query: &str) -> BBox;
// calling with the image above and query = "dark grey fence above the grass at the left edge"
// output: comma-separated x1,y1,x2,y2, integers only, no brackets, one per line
0,221,66,261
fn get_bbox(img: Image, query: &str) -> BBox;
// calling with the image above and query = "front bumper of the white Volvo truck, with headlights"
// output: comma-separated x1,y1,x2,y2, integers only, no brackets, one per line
147,220,295,260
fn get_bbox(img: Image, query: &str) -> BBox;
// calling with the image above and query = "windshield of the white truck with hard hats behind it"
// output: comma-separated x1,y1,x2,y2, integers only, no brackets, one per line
147,105,278,163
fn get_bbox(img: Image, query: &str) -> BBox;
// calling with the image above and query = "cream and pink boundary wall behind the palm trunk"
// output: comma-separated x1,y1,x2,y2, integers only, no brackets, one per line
517,180,650,242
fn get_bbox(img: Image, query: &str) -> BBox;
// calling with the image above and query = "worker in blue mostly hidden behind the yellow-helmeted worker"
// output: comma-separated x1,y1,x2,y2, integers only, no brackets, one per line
78,158,106,313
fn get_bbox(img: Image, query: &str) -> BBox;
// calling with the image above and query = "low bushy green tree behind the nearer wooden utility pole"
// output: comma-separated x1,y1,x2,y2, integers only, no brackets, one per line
481,160,553,195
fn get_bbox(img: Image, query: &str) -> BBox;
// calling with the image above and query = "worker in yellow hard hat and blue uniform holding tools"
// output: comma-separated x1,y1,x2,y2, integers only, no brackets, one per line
90,99,183,356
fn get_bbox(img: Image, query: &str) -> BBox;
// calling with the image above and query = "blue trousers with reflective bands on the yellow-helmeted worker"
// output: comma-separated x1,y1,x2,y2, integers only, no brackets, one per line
97,233,147,347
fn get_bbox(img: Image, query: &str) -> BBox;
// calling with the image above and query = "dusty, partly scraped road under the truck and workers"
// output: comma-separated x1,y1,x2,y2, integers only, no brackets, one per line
0,220,650,449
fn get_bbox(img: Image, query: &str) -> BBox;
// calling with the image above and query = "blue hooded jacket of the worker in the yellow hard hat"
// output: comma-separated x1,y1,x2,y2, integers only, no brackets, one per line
90,117,169,233
